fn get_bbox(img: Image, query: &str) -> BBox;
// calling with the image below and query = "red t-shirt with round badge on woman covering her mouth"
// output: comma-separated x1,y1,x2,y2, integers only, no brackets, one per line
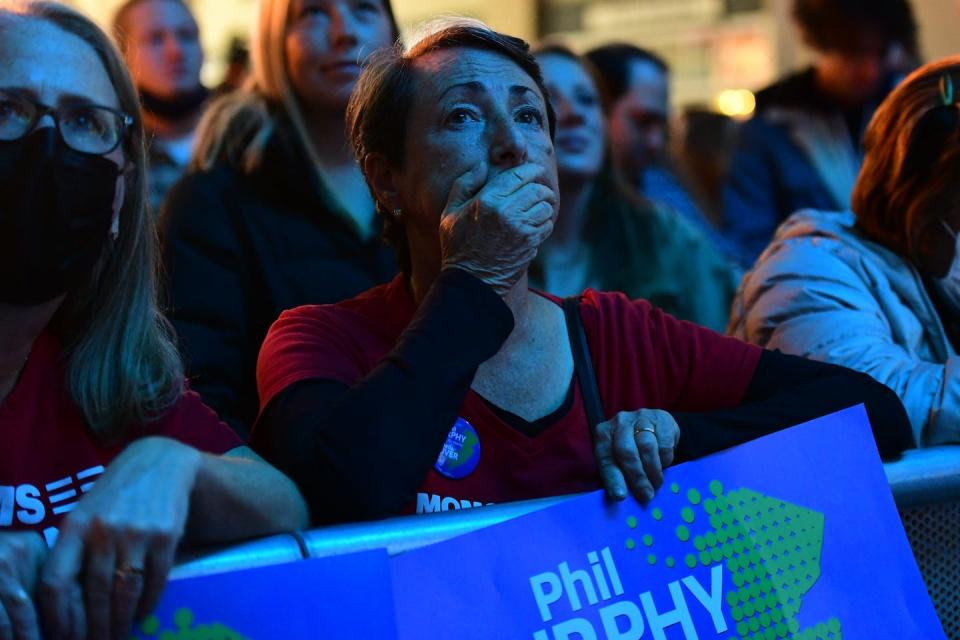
257,276,761,513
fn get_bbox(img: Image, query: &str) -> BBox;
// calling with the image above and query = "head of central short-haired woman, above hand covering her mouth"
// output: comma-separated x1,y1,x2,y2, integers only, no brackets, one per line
394,48,558,250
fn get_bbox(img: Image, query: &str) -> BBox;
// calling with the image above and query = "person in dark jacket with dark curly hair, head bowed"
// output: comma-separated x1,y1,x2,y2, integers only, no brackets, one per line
723,0,917,266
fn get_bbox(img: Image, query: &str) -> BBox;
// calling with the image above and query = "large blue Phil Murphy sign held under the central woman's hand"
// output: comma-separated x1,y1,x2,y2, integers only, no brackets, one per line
392,407,944,640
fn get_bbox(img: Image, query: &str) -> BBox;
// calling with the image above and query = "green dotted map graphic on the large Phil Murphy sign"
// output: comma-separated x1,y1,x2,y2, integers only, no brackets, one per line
625,480,843,640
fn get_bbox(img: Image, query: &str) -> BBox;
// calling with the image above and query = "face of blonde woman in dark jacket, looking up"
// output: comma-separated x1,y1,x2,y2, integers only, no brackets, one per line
285,0,394,111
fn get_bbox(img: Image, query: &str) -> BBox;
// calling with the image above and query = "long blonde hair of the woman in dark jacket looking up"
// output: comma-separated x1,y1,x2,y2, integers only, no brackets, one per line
188,0,398,173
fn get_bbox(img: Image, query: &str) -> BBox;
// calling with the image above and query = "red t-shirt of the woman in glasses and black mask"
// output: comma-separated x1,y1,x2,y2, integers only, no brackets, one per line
0,334,243,545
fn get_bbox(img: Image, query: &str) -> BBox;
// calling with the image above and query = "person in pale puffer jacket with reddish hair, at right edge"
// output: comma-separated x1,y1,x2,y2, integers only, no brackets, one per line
731,56,960,446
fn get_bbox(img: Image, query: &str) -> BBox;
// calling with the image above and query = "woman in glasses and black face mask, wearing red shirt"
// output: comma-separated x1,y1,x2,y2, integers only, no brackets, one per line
0,0,306,640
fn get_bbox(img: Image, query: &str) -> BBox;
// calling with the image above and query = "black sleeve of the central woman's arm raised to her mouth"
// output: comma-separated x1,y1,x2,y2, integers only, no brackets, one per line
253,272,513,522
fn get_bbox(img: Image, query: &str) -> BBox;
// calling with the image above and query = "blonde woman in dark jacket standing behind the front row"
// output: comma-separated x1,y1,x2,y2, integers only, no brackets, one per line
161,0,397,437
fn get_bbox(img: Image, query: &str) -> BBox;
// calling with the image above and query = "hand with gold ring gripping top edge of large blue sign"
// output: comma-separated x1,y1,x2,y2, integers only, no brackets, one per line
594,409,680,504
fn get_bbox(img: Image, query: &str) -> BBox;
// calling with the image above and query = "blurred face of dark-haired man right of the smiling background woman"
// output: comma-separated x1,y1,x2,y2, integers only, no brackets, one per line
609,60,670,179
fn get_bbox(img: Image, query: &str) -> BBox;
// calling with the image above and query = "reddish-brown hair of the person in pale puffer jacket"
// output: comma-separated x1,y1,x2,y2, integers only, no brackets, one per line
852,56,960,262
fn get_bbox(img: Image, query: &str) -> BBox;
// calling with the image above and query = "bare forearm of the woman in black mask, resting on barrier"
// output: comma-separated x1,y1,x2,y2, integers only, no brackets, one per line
186,447,308,544
